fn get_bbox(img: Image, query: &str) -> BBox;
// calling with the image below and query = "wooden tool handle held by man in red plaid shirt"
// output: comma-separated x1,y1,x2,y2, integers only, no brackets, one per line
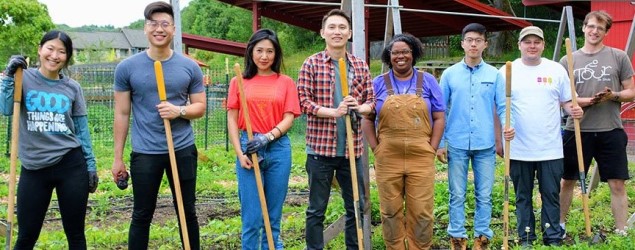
339,58,364,250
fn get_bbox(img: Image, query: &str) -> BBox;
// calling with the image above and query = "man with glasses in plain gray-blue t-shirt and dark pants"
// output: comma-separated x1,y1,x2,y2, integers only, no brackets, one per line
112,1,206,249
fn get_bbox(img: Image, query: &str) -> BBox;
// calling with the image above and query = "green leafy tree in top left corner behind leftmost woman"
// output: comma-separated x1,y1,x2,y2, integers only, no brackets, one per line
0,0,55,62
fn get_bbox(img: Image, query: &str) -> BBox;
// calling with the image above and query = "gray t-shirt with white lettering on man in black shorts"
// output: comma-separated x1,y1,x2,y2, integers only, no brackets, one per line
560,46,633,132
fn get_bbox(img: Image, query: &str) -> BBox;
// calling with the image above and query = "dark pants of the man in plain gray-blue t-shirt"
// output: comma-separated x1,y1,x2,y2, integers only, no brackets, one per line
128,145,200,250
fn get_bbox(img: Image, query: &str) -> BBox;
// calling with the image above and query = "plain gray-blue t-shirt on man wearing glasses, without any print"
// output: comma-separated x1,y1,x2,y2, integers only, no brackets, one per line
114,52,205,154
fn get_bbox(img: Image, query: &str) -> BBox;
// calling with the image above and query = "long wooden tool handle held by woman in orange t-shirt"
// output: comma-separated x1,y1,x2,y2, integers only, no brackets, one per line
234,63,275,249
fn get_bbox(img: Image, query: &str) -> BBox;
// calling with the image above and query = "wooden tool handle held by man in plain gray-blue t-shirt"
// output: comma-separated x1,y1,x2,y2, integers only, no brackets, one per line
154,61,190,250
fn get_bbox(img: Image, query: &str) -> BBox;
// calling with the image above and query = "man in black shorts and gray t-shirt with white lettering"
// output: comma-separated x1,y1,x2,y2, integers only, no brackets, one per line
560,11,635,234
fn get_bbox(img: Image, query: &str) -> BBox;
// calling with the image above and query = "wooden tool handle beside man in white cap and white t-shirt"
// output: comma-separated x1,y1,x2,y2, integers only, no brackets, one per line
504,61,512,250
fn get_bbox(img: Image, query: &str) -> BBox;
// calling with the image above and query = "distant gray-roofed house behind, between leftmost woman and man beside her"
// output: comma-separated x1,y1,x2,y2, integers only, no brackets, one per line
68,29,148,64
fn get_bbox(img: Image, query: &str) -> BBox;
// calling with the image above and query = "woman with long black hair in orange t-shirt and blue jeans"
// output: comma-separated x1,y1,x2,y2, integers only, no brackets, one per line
227,29,300,249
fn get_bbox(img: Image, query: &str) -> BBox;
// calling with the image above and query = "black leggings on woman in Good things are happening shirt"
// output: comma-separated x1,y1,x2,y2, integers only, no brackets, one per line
15,148,88,249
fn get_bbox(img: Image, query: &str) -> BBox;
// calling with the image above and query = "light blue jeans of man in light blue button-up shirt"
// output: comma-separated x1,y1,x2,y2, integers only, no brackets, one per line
447,146,496,239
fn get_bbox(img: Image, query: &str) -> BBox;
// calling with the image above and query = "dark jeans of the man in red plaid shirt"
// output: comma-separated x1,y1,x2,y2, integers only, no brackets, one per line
305,155,364,250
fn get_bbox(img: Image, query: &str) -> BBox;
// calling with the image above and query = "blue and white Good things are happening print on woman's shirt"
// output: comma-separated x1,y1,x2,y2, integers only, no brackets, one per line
24,90,71,134
